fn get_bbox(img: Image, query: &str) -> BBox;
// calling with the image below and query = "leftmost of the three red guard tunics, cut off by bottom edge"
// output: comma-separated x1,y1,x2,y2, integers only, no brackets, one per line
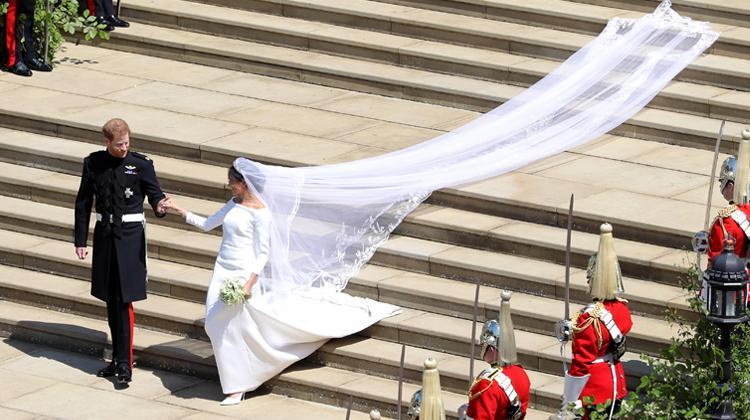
466,365,531,420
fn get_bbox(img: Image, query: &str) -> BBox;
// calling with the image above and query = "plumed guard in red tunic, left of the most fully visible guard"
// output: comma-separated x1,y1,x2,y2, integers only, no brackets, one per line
466,291,531,420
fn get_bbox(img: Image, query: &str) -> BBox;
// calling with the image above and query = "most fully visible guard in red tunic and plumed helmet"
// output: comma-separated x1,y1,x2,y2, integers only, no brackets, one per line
563,223,633,418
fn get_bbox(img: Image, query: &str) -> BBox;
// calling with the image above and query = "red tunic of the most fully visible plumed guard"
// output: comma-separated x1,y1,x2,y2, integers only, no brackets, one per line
568,299,633,405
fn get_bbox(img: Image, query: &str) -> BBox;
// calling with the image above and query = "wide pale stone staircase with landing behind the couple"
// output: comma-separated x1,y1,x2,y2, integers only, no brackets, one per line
0,0,750,418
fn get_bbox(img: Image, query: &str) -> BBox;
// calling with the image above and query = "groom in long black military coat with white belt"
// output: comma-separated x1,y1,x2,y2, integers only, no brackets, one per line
74,118,166,384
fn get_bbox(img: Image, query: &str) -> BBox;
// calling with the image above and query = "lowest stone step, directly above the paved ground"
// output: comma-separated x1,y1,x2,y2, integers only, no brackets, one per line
0,300,560,420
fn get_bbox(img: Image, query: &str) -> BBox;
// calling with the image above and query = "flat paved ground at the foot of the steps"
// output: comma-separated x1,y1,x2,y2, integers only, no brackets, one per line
0,339,376,420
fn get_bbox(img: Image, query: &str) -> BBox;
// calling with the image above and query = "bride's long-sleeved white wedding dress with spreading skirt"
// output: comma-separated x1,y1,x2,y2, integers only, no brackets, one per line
185,200,399,394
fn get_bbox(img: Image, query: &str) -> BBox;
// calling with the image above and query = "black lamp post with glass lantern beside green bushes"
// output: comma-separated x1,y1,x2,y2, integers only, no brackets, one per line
703,237,748,420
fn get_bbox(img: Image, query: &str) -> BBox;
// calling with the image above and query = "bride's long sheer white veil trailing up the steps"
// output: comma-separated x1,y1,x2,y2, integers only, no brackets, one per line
235,1,718,298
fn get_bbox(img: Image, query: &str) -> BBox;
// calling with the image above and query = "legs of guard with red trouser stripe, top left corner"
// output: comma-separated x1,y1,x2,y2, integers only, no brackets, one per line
4,0,52,77
